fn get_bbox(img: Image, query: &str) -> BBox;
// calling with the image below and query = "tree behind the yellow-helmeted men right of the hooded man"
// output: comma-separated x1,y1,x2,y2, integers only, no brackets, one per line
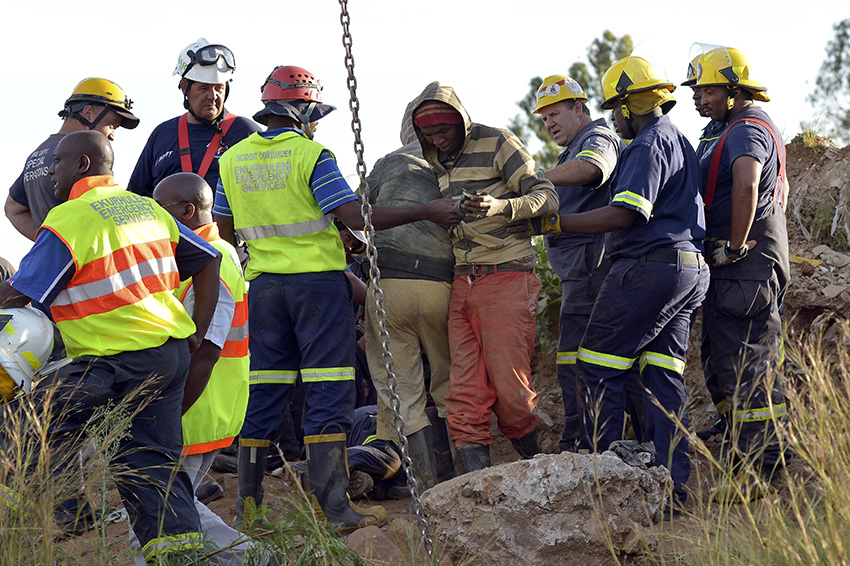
508,30,632,170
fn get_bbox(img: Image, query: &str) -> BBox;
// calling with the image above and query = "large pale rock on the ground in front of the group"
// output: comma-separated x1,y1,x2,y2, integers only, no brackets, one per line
422,452,670,566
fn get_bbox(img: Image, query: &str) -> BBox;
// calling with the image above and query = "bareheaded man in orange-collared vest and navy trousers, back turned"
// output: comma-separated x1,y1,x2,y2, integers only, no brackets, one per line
0,132,219,564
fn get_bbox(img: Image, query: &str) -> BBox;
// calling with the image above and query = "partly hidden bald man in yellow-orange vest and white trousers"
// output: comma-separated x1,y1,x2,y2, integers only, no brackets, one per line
125,173,250,566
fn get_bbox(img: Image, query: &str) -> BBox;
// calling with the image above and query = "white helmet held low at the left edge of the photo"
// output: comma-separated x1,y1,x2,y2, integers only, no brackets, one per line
0,307,53,401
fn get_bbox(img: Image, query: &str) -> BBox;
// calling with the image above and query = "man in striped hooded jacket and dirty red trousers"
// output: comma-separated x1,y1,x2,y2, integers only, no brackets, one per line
413,82,558,472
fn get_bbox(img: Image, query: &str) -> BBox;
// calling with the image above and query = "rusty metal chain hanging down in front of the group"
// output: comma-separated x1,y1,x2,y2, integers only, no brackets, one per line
339,0,440,565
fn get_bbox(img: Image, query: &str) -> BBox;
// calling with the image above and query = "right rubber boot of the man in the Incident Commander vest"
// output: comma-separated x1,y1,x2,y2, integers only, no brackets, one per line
304,425,387,532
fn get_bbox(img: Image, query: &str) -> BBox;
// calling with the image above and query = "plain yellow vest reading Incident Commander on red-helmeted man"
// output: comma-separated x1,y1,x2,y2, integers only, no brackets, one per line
219,131,345,281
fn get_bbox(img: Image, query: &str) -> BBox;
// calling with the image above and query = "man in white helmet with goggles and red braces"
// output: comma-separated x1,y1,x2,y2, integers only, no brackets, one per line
127,37,260,197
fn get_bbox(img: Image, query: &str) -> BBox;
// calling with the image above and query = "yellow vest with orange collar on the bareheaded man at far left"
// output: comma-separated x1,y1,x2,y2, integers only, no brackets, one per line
42,175,195,356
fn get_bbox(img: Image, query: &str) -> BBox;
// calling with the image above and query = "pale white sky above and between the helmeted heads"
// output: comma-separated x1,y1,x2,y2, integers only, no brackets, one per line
0,0,850,266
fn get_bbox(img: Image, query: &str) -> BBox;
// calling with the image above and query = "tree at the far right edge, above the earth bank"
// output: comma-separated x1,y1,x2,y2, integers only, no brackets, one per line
808,19,850,143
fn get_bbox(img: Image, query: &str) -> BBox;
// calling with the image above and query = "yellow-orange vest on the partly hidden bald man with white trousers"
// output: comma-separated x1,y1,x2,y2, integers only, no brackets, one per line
176,223,249,456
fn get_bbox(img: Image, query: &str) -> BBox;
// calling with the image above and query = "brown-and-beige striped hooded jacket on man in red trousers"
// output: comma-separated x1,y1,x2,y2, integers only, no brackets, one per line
410,82,558,269
